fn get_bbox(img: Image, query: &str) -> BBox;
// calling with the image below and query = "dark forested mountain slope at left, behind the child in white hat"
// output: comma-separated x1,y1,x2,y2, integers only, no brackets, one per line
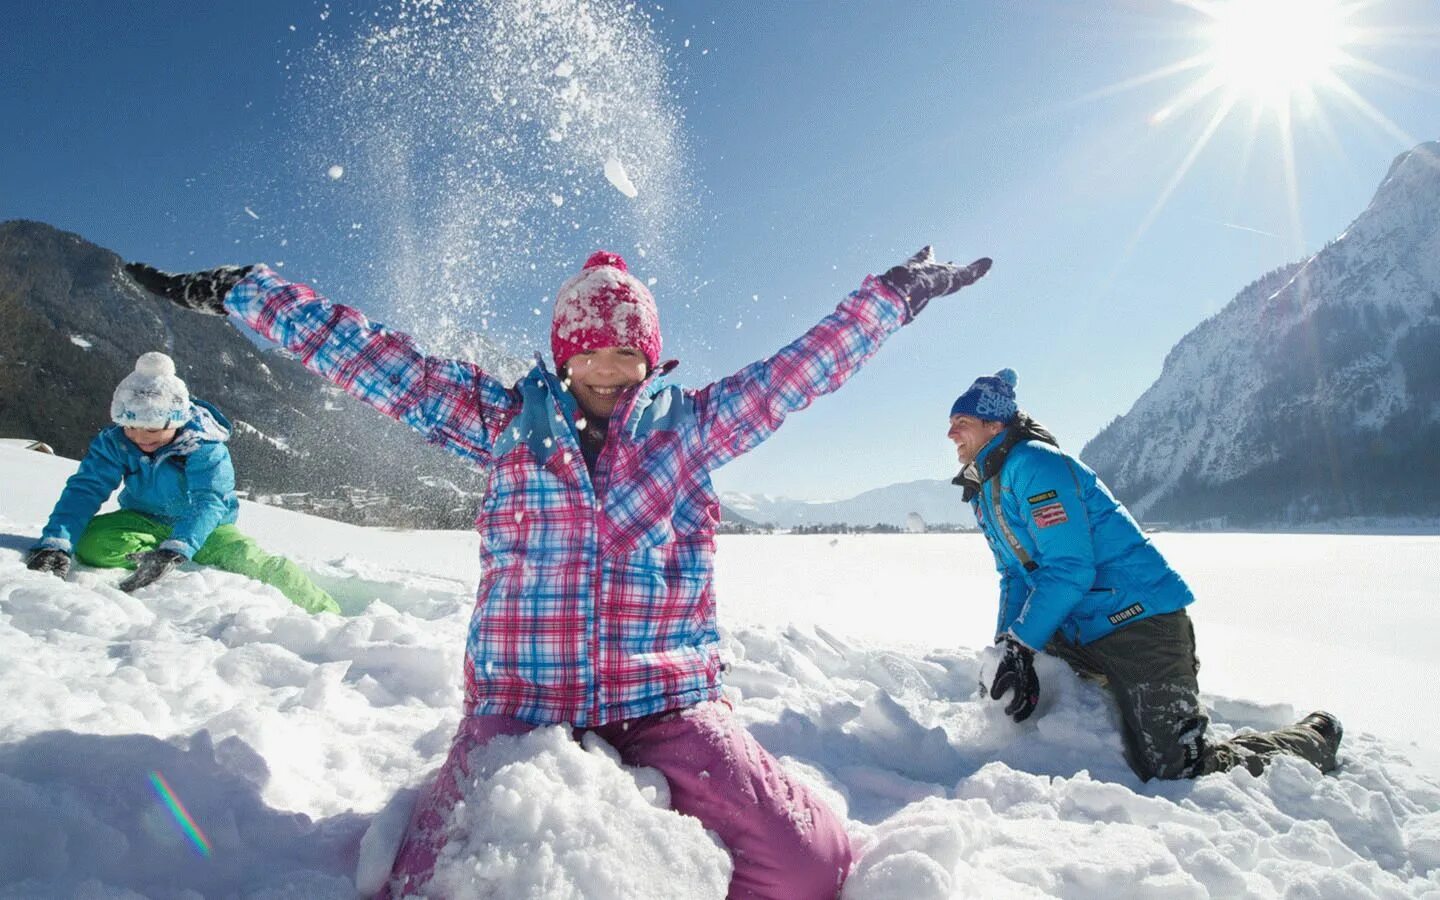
0,220,527,527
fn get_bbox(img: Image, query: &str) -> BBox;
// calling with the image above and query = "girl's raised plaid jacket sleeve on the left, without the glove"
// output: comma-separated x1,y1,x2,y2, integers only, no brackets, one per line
225,266,520,464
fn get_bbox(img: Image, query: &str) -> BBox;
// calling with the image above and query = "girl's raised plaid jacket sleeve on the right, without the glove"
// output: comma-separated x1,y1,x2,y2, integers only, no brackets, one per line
696,276,909,469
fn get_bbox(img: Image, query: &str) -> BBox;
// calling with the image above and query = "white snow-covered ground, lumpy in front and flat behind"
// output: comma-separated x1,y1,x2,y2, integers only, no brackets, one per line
0,446,1440,900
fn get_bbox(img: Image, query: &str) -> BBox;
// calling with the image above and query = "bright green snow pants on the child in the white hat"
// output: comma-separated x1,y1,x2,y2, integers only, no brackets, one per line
75,510,340,612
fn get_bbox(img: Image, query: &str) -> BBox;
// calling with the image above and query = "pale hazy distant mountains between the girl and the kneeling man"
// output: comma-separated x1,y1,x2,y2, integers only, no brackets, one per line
720,478,975,528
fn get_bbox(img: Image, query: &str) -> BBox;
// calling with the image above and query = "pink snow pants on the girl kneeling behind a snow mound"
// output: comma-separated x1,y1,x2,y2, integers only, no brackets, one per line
379,703,851,900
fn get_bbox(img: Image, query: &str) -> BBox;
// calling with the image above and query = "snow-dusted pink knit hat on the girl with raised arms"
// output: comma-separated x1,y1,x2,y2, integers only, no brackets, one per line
550,251,660,370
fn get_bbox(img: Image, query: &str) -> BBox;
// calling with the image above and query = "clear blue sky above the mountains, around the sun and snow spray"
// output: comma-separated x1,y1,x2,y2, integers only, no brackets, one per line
0,0,1440,498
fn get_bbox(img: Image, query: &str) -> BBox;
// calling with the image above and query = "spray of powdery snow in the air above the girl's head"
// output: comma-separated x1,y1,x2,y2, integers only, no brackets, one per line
285,0,696,356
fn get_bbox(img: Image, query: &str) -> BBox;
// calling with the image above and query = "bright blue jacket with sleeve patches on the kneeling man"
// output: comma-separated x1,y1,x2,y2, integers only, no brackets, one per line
956,417,1195,649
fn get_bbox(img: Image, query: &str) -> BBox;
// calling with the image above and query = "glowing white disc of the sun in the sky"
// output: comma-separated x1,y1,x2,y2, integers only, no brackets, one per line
1195,0,1355,114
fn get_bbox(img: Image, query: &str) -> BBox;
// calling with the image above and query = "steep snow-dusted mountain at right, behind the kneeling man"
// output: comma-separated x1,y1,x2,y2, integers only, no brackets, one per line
1083,143,1440,526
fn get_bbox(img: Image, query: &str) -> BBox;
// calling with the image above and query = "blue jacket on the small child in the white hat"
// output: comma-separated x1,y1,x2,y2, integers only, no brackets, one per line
37,399,239,557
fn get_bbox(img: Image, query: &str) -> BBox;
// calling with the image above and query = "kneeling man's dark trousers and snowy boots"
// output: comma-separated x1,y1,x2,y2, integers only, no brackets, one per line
1045,609,1336,780
